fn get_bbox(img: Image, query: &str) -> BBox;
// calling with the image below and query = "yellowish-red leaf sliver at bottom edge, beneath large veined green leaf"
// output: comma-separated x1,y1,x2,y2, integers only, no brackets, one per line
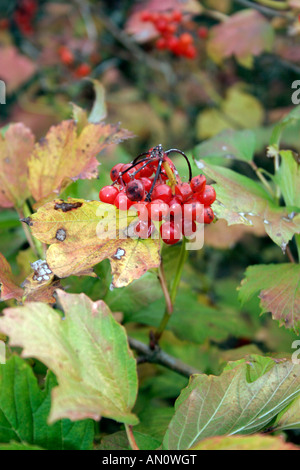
190,434,300,450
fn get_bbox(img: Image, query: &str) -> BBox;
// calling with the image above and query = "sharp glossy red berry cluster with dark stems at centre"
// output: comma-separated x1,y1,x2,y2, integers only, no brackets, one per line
99,145,216,245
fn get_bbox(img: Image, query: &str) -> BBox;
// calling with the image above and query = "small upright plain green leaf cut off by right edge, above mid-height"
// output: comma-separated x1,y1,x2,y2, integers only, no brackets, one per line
277,150,300,207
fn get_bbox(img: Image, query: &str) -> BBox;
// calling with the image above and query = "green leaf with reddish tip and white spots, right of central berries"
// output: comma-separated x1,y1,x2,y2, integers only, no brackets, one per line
198,161,300,251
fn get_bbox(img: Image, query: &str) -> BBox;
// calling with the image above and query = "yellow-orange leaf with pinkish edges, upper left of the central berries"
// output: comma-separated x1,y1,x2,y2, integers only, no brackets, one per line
28,120,132,201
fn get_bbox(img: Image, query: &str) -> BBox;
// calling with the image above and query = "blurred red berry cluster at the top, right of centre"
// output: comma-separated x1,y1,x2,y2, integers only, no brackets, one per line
141,10,197,59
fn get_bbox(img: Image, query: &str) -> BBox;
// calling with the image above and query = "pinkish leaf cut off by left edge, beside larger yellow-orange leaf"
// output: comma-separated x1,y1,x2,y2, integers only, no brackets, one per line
0,124,34,207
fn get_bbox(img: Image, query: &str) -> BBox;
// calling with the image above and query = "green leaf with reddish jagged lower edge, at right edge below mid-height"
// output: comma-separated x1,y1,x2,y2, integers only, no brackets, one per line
239,263,300,329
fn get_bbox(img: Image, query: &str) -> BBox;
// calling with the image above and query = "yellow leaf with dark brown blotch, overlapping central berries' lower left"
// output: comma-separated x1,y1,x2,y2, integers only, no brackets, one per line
27,198,160,287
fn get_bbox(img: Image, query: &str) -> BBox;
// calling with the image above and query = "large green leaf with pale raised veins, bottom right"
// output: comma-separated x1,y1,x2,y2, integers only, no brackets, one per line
163,356,300,450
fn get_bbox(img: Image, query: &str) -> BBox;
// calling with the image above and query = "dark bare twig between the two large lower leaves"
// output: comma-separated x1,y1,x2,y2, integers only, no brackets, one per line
128,338,201,377
